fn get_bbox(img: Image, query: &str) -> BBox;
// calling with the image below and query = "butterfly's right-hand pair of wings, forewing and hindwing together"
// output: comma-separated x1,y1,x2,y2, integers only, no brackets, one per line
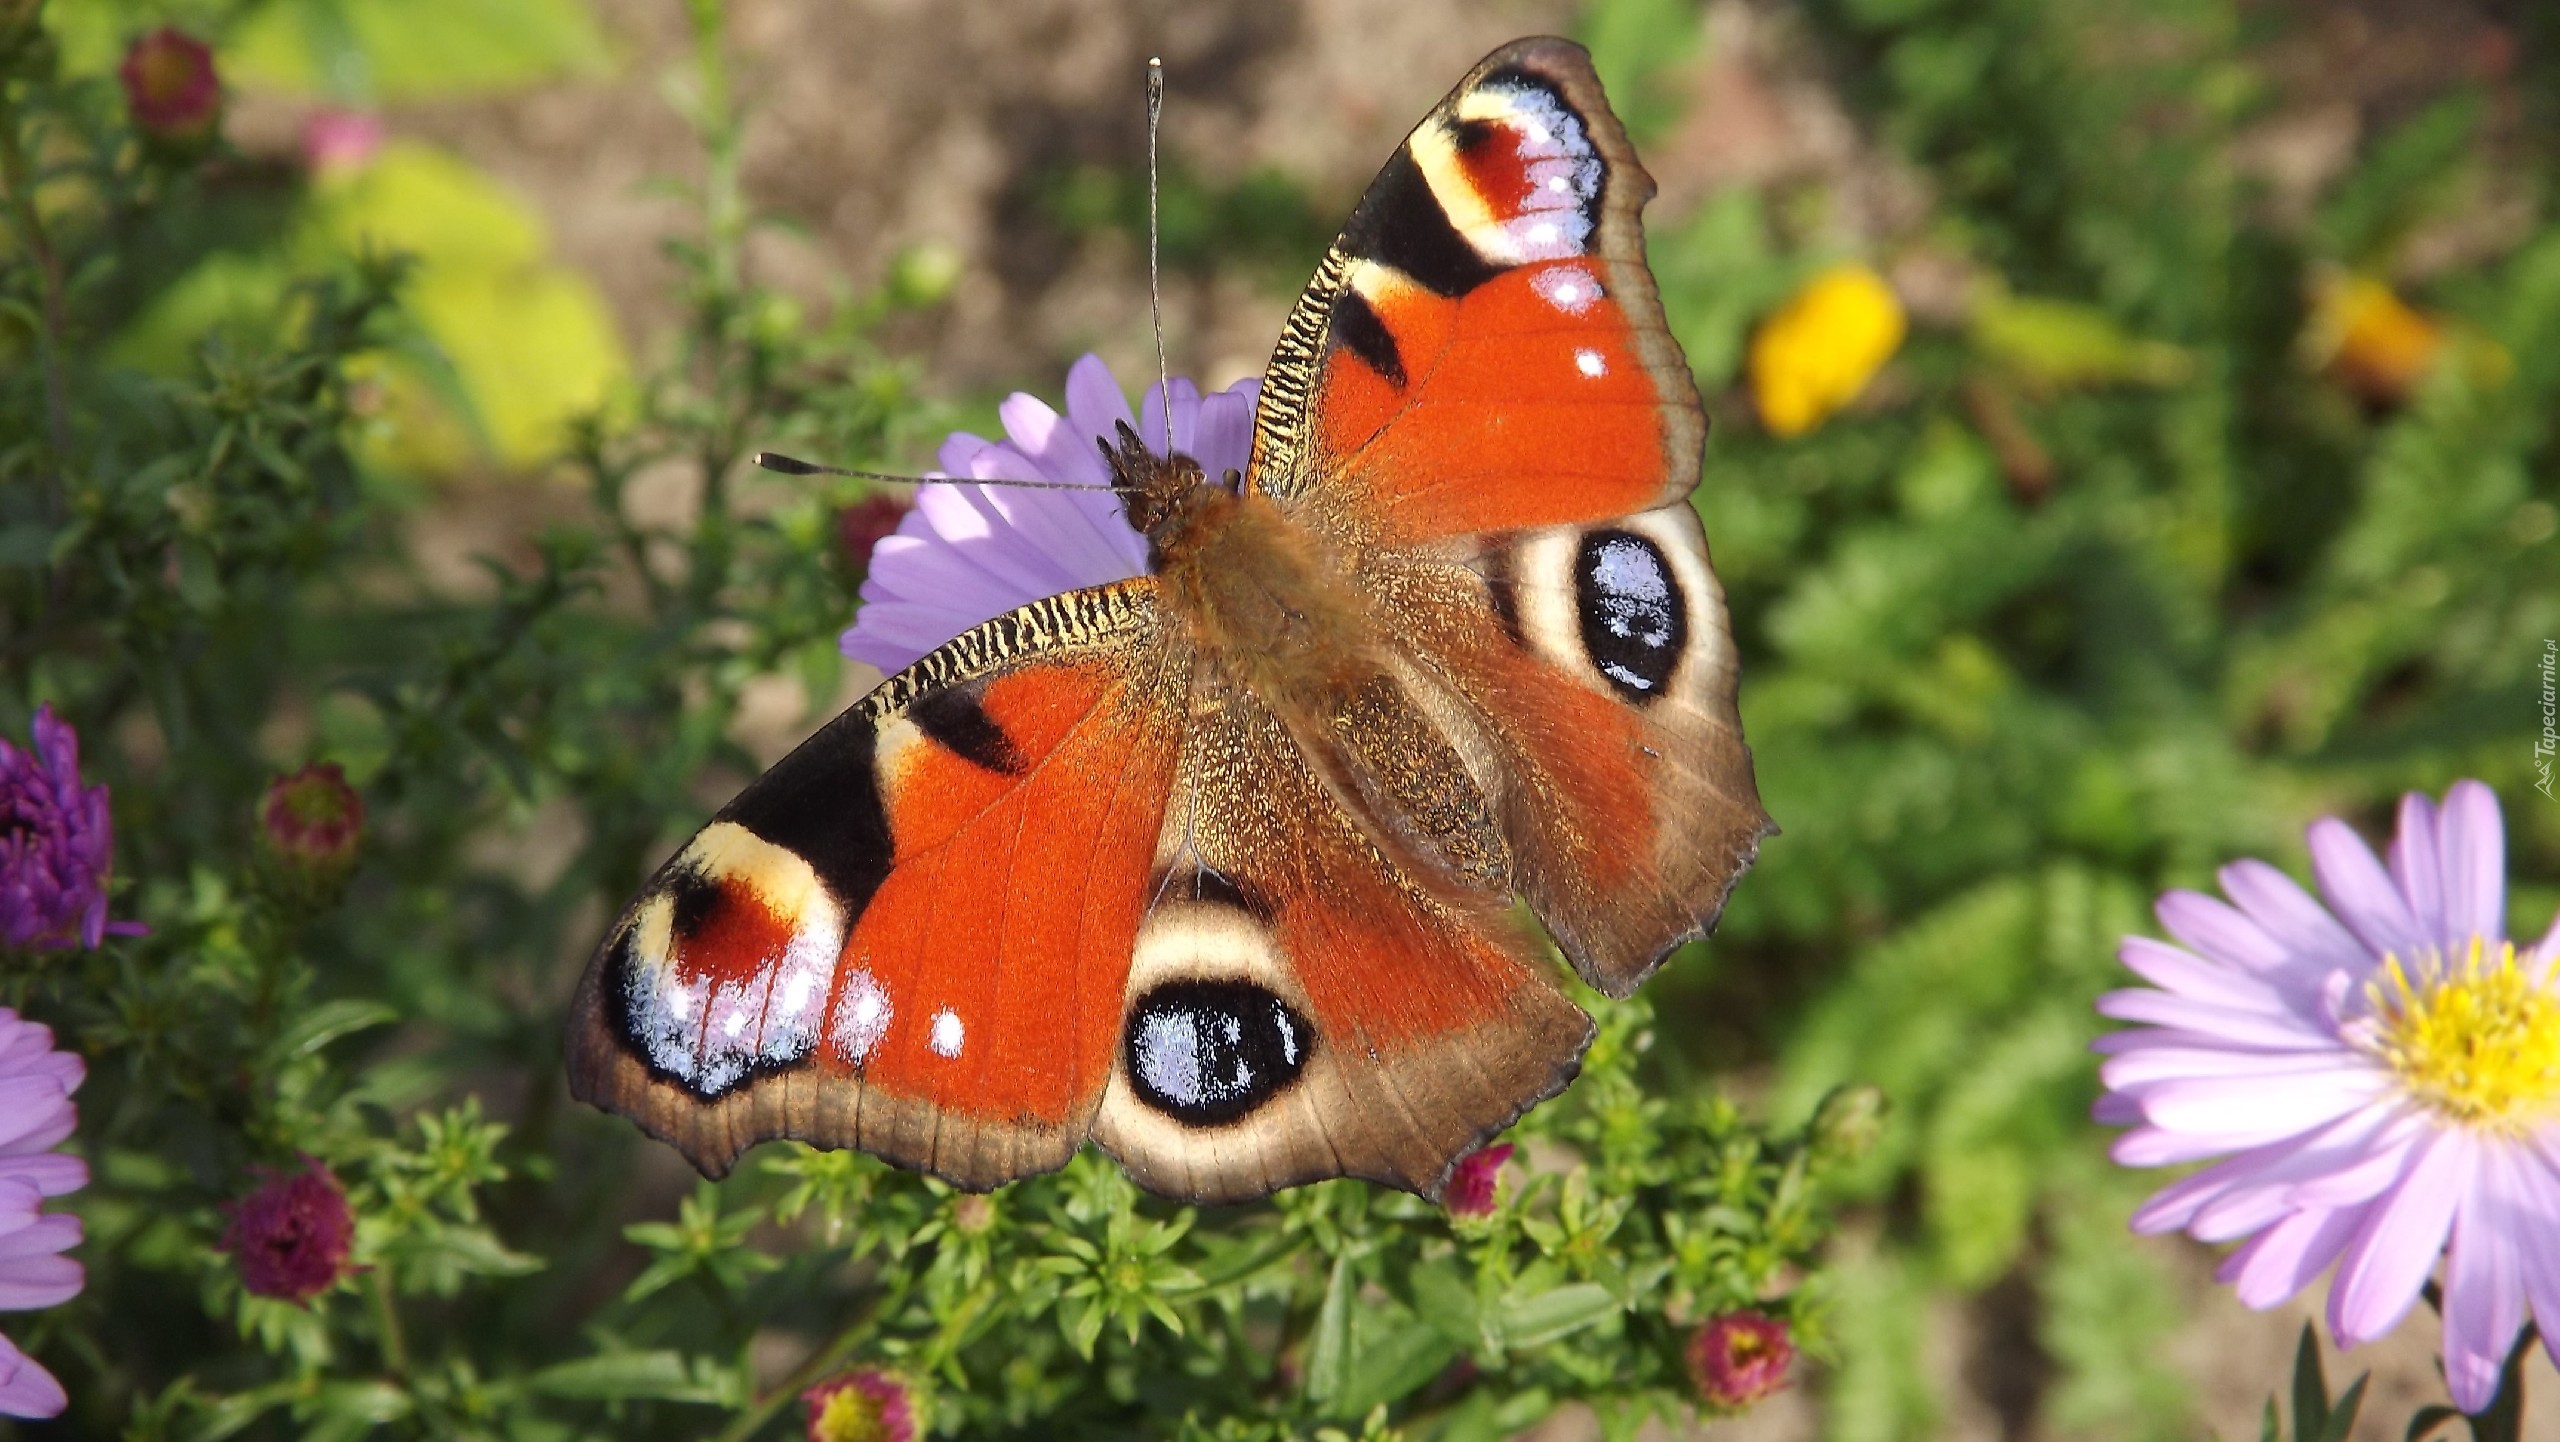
1249,38,1774,996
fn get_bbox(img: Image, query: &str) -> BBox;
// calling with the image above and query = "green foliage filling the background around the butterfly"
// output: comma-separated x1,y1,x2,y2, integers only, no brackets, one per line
0,0,2560,1439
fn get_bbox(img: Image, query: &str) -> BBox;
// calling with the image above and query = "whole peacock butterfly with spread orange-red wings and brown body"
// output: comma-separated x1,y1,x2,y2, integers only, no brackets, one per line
571,38,1774,1201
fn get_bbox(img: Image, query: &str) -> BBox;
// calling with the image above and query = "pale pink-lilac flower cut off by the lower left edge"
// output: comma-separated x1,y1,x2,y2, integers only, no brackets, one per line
0,1007,90,1416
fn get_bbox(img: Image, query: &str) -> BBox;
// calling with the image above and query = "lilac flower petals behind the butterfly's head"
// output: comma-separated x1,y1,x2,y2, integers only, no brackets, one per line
842,356,1262,671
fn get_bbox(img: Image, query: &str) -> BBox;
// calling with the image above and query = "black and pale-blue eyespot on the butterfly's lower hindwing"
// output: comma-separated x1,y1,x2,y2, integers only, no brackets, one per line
1121,978,1316,1127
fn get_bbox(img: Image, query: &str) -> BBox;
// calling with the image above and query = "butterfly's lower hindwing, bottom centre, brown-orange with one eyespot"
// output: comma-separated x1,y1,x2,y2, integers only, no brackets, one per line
1096,686,1592,1201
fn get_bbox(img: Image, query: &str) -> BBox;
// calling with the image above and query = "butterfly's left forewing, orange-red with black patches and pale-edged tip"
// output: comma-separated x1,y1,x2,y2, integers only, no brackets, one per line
571,581,1188,1188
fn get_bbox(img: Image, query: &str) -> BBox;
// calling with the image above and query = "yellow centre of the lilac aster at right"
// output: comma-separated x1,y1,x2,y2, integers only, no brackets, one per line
2368,937,2560,1132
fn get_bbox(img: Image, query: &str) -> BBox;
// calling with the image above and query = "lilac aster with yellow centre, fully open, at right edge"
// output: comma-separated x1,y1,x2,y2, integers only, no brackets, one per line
2097,781,2560,1411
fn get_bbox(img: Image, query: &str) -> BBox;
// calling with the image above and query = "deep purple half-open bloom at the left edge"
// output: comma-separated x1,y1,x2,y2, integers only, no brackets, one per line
0,707,143,950
